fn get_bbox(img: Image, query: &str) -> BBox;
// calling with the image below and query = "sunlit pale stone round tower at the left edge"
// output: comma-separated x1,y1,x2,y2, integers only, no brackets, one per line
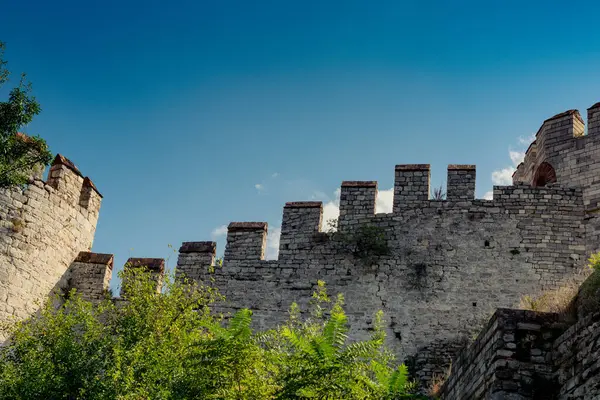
0,155,102,326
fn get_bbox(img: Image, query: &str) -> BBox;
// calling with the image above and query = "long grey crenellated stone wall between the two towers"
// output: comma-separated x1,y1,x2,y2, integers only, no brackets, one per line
177,165,586,380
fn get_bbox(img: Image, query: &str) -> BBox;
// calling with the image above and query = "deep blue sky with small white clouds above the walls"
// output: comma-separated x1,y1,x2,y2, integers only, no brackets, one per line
0,0,600,292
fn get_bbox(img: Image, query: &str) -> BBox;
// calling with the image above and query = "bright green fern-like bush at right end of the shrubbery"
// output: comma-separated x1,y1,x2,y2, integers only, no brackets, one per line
275,281,416,399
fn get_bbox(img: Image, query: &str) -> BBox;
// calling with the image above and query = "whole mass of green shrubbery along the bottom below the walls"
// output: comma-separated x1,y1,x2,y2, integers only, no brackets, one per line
0,269,417,400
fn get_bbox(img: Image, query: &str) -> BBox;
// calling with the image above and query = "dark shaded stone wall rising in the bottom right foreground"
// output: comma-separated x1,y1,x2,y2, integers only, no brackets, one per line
441,272,600,400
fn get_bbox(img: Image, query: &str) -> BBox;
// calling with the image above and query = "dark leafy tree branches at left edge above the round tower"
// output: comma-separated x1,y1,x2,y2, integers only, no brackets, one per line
0,42,52,187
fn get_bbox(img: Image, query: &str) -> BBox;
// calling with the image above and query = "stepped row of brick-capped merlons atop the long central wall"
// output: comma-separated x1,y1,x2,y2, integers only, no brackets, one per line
188,164,584,262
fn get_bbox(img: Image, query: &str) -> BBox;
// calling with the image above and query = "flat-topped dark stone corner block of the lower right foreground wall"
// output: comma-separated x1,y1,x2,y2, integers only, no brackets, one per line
441,309,565,400
